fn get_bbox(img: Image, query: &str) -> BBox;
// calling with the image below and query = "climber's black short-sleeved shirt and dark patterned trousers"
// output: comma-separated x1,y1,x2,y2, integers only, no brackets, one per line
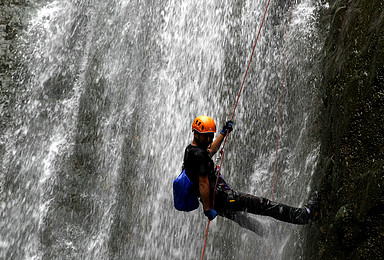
183,145,311,226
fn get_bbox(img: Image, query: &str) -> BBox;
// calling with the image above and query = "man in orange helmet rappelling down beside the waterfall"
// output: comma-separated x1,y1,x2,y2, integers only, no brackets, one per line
173,116,320,235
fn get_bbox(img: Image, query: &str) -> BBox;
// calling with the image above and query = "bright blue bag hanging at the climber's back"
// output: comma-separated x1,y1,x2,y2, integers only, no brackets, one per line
173,170,199,211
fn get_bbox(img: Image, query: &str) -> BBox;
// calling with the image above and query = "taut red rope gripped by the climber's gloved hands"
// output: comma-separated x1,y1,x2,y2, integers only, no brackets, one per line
201,0,271,260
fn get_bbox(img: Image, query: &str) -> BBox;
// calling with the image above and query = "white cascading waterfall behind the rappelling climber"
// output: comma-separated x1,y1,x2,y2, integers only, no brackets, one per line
0,0,322,259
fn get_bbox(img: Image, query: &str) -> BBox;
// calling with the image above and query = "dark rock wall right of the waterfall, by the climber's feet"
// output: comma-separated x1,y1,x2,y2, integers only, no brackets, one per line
307,0,384,259
